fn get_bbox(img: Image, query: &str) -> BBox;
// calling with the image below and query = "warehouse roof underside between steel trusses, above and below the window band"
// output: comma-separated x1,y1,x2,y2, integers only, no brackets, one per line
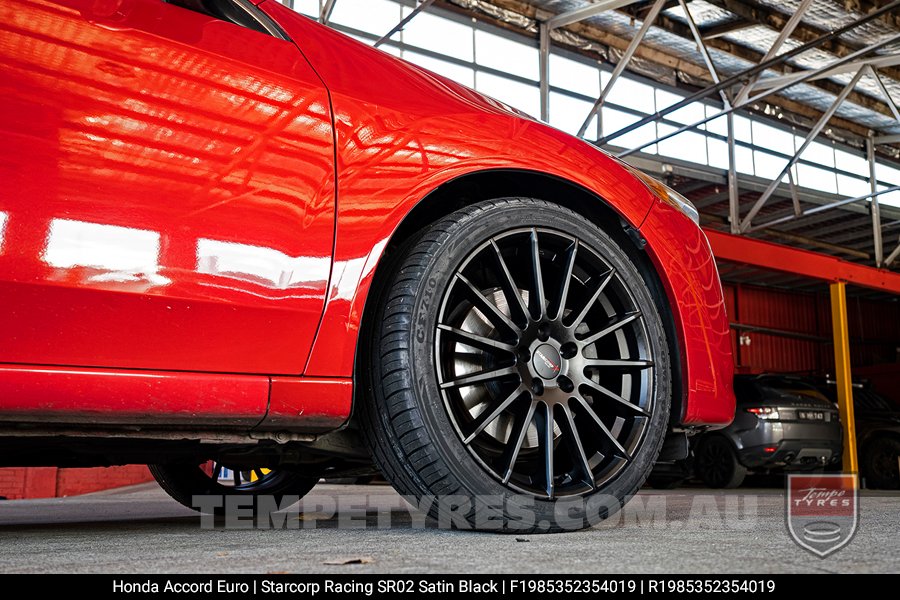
437,0,900,278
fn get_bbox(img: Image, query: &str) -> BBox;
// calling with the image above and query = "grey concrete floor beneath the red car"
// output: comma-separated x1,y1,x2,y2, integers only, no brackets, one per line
0,484,900,574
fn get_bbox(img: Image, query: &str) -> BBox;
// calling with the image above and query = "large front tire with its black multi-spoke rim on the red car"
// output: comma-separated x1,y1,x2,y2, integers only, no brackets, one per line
360,198,671,532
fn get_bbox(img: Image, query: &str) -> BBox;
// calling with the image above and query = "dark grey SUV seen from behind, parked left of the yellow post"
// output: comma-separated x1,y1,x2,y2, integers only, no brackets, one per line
676,375,843,488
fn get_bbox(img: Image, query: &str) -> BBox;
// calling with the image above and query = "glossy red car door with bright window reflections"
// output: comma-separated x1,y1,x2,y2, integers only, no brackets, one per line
0,0,335,374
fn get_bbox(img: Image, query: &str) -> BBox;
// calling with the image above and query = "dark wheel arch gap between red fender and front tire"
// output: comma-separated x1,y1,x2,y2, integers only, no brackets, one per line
353,169,687,427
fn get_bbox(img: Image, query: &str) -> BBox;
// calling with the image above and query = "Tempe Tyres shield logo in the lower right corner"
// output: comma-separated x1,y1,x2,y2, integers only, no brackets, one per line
786,475,859,558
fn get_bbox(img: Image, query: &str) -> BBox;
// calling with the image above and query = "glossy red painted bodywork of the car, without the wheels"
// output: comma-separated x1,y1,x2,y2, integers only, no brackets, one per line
0,0,733,431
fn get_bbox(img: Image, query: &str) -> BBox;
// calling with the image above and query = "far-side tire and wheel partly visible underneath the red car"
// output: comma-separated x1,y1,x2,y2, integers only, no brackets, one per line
148,463,319,515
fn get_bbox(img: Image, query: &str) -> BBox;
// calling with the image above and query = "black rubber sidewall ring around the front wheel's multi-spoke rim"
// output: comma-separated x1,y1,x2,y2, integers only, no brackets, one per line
400,199,671,530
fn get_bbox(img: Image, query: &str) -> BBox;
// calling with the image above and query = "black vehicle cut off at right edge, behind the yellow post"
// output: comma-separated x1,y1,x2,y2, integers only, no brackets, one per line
816,380,900,490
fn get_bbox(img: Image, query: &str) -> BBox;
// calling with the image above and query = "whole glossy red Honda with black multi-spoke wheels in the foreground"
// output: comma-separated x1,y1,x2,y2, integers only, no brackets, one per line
0,0,734,531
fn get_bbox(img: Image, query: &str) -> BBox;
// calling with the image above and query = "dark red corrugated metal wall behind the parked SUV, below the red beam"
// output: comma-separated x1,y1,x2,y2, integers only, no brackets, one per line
725,284,900,378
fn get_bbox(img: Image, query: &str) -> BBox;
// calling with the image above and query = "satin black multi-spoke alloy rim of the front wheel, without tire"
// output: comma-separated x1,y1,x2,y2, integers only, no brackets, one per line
435,227,654,498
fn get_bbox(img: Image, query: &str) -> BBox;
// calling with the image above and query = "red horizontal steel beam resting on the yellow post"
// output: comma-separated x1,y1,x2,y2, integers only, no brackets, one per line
704,229,900,294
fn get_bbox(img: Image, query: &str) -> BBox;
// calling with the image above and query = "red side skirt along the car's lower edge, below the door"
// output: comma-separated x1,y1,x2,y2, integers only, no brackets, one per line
0,364,353,437
